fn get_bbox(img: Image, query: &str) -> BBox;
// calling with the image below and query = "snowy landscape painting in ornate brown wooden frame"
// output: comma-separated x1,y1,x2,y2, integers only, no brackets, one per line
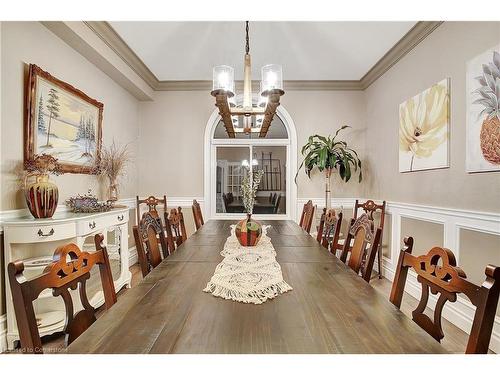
24,64,104,173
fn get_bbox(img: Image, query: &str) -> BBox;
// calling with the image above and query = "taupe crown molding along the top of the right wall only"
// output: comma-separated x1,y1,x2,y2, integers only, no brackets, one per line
359,21,443,90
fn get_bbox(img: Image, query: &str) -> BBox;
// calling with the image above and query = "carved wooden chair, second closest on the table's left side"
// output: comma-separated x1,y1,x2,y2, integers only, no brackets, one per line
132,211,169,277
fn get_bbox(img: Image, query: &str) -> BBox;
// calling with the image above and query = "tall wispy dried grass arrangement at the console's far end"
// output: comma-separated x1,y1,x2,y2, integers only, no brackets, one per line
92,141,131,201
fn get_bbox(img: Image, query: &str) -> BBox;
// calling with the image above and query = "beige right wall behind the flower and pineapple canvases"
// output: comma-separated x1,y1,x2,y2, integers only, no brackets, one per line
365,22,500,212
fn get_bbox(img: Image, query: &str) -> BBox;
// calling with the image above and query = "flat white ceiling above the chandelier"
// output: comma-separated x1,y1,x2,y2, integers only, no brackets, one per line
110,22,416,81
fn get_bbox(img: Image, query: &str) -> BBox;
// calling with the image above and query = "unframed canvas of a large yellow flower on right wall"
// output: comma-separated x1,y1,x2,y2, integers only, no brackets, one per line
399,79,450,172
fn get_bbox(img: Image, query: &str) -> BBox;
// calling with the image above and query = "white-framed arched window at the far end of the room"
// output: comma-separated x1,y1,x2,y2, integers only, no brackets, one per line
204,101,297,219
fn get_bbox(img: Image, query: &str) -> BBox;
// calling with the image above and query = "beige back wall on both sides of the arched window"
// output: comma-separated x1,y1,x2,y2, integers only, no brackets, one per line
138,87,366,197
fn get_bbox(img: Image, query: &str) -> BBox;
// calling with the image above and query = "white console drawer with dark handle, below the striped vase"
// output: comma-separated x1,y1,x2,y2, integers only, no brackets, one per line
8,223,76,243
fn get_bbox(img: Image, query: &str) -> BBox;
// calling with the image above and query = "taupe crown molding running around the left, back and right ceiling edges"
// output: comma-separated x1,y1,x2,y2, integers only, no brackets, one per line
73,21,443,91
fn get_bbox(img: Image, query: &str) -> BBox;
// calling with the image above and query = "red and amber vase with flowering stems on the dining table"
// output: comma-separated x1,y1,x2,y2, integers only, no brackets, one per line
235,167,264,246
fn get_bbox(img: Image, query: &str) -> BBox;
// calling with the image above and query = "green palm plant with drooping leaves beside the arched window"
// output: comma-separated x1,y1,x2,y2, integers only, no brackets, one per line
295,125,363,209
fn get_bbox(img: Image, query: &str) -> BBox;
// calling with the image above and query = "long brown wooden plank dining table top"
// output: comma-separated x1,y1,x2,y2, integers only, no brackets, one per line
67,220,446,353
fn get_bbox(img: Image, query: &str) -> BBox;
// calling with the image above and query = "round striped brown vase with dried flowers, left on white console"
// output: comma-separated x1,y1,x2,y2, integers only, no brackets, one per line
24,154,61,219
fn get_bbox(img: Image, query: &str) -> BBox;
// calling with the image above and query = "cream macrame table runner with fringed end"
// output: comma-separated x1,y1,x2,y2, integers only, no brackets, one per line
203,225,292,304
